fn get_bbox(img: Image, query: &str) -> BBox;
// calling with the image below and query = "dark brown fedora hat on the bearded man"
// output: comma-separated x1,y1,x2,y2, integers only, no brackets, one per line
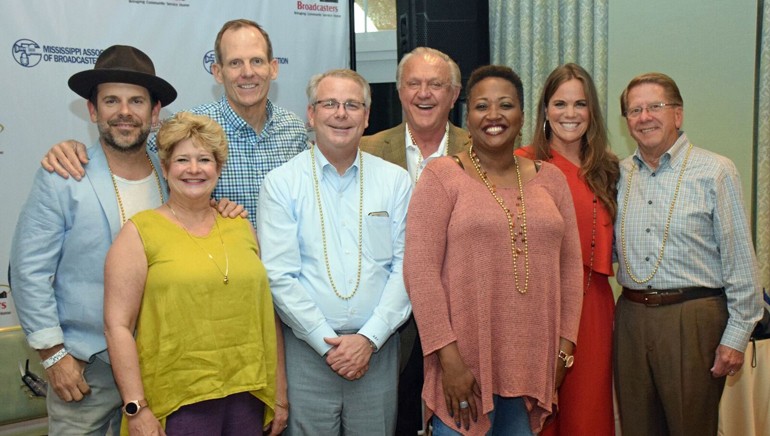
67,45,176,106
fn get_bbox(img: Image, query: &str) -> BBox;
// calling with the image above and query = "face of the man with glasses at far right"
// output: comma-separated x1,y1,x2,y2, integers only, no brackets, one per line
626,83,684,161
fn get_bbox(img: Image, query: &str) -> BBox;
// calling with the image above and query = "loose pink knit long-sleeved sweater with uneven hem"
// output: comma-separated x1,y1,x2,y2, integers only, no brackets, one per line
404,158,583,435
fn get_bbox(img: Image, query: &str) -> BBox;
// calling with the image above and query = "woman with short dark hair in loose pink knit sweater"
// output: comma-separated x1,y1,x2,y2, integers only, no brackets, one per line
404,65,583,436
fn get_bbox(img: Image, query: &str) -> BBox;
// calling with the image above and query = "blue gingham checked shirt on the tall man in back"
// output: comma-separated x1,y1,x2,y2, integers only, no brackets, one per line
148,96,307,226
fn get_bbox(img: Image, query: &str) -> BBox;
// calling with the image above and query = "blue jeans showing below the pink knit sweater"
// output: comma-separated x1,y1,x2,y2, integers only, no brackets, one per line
431,395,532,436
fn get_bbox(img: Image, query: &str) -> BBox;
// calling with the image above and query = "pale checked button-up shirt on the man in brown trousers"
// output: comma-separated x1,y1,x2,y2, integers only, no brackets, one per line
615,133,762,352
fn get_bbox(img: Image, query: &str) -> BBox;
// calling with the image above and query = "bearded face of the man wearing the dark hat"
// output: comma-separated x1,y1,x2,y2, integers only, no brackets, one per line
88,83,160,153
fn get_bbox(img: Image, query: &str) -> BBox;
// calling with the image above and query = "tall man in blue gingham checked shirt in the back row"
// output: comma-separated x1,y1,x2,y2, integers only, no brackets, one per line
41,19,307,226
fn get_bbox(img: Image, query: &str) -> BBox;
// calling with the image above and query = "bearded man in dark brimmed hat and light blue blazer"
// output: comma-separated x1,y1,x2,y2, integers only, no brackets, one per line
11,45,177,435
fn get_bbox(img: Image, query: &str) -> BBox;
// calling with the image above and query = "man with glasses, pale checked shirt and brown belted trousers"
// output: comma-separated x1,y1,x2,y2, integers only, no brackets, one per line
614,73,762,436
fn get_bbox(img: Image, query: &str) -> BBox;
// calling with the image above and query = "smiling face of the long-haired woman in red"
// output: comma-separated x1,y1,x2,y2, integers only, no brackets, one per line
546,79,591,150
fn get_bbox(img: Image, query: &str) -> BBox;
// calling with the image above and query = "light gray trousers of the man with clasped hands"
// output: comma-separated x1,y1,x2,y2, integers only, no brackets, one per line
283,325,399,436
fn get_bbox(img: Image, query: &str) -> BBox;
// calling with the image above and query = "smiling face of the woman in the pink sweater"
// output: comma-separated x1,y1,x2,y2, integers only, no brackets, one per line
468,77,524,152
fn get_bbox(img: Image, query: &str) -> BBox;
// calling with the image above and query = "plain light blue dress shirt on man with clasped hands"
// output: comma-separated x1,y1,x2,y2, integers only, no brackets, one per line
257,148,411,356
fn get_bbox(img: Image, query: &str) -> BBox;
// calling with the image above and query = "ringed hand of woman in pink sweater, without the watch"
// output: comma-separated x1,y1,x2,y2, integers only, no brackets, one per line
438,342,481,430
